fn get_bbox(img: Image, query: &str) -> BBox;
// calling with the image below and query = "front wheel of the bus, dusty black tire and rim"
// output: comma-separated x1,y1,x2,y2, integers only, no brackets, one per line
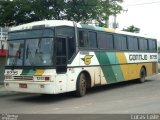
76,73,87,97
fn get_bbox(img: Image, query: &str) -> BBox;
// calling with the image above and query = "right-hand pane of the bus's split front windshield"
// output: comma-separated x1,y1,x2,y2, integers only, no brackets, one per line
24,38,53,66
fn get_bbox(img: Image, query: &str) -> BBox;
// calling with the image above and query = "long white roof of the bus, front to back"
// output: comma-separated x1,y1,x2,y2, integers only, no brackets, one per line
10,20,155,39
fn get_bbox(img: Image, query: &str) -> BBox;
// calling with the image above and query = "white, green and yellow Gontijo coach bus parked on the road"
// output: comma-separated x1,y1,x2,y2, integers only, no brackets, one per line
4,20,158,97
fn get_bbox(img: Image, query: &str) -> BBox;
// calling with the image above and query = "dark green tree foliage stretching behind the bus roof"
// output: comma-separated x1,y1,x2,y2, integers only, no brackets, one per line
0,0,123,26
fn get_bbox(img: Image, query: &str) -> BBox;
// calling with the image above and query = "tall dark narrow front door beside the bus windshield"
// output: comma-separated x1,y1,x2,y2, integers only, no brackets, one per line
55,37,67,73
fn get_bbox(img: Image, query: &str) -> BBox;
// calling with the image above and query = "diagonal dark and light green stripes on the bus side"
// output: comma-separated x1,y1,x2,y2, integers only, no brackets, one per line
96,52,124,83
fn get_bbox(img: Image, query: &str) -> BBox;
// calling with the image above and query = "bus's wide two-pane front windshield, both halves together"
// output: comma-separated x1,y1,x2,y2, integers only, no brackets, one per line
7,31,54,66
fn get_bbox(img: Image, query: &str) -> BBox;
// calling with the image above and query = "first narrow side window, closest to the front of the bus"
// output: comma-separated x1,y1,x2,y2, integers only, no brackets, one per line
79,30,88,47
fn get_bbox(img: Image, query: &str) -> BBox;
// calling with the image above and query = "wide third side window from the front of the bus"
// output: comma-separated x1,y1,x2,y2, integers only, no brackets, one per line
98,33,113,49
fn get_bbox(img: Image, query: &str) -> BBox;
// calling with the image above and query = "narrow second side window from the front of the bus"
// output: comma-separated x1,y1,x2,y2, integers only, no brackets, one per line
88,32,97,48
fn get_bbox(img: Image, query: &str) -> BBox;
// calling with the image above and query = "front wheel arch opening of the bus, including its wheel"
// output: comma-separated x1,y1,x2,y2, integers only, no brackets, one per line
76,71,91,97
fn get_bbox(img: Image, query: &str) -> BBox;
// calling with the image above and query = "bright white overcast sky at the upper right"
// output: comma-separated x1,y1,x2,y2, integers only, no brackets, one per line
111,0,160,41
